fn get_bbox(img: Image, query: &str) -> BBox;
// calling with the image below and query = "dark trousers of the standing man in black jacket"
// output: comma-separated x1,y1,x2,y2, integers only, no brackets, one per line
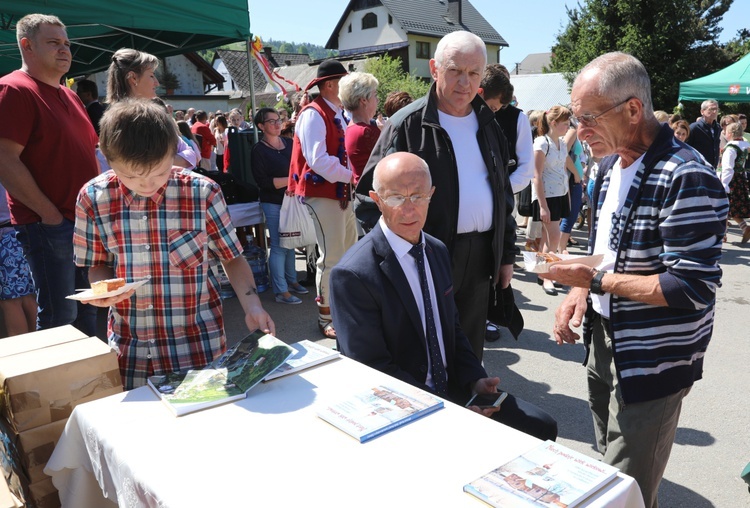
451,230,494,362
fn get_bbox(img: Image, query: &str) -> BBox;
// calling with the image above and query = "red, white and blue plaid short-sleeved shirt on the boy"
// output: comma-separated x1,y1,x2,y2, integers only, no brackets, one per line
73,171,241,389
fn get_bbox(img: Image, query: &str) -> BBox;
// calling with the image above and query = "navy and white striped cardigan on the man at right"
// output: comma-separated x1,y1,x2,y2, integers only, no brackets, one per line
584,125,728,403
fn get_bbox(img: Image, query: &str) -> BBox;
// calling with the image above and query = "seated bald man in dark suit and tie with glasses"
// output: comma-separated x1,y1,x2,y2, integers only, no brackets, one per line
330,152,557,439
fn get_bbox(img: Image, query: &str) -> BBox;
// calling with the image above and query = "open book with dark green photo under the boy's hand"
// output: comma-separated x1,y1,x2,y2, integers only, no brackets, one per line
148,330,295,416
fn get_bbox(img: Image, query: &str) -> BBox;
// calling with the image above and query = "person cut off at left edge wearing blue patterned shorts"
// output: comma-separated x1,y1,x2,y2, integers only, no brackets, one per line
0,181,37,337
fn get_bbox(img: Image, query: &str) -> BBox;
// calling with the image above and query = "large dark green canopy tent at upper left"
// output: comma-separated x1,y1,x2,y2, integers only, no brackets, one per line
0,0,251,76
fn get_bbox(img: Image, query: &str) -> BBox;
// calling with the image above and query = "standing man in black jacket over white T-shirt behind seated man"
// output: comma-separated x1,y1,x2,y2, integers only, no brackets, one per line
357,31,516,360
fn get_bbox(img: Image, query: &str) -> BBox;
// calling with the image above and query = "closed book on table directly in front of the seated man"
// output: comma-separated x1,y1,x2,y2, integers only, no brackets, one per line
317,385,443,443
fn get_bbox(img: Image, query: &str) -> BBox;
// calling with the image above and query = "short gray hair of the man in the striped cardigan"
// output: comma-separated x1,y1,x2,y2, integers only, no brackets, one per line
573,51,654,114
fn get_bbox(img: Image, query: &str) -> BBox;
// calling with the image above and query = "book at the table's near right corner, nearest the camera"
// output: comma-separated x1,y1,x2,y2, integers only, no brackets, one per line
464,441,619,508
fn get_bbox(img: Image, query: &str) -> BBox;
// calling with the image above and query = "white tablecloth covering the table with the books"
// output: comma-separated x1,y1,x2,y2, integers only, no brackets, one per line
45,358,643,508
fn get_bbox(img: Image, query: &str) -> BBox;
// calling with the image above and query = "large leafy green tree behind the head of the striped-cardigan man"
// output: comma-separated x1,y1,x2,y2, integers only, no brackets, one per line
548,0,733,111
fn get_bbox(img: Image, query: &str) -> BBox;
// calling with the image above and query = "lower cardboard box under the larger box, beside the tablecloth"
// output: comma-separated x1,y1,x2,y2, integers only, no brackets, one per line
0,420,67,483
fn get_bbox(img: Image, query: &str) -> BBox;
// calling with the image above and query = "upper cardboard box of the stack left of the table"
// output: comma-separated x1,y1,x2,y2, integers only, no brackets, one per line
0,332,122,433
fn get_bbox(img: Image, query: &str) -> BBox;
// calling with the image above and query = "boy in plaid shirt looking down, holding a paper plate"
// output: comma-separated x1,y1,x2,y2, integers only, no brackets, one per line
73,100,275,389
